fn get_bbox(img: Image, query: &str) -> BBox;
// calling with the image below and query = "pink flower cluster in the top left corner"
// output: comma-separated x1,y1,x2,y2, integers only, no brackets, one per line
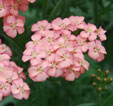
0,0,35,38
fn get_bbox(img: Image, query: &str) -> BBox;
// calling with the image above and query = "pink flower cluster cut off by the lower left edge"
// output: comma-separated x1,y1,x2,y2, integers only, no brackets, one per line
0,40,30,101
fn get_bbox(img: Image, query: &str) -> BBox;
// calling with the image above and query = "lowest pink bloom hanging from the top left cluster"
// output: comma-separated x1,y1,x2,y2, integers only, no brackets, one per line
4,15,24,38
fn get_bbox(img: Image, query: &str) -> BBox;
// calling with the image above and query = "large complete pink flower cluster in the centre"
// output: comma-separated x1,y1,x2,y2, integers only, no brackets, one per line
22,16,106,82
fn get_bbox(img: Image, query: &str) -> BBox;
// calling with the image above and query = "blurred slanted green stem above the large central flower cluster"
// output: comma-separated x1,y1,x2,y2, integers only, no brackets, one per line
48,0,64,21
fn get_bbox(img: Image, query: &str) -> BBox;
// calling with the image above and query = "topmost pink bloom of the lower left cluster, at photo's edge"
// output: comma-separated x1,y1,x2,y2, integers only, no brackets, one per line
0,44,12,56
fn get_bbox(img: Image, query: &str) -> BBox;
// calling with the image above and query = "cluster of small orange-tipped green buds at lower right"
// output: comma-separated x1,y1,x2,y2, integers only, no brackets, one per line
91,69,113,92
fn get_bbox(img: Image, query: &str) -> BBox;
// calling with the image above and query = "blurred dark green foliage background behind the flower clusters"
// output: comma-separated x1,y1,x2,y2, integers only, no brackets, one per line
0,0,113,106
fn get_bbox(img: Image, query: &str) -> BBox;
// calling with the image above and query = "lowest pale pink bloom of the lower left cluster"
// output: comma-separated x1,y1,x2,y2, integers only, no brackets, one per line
11,79,30,100
